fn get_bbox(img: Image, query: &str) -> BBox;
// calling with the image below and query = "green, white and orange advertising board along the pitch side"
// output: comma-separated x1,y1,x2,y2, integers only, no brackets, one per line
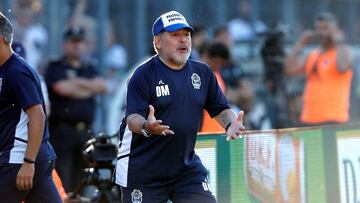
196,124,360,203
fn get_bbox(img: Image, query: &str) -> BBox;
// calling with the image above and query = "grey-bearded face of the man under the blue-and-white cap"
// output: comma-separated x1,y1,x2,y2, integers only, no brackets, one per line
155,28,191,65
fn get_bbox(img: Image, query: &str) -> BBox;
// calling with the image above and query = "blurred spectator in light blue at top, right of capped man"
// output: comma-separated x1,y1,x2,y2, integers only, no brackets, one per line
228,0,266,42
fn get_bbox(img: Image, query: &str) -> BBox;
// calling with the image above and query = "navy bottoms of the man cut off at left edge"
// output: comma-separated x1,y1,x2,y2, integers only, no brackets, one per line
0,161,62,203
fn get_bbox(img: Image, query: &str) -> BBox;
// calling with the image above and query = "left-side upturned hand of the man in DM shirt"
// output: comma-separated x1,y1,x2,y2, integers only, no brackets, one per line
145,105,174,135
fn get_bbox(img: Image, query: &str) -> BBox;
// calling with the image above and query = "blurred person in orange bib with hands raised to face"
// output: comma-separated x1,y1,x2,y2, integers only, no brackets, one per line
285,13,353,125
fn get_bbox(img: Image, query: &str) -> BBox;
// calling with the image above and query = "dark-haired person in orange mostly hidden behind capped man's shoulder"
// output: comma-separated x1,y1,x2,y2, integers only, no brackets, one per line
200,42,230,133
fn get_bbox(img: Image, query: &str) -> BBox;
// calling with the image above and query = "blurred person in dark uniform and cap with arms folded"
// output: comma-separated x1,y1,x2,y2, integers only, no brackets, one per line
45,27,106,192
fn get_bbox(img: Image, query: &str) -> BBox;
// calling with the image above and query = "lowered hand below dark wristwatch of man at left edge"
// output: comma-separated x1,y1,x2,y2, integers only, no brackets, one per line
16,162,35,190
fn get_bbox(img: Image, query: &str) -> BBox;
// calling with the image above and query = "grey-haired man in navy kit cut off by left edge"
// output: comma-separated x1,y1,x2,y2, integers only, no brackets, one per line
0,13,61,203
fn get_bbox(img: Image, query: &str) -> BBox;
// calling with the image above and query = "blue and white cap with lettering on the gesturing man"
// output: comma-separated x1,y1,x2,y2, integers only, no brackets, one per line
152,11,194,36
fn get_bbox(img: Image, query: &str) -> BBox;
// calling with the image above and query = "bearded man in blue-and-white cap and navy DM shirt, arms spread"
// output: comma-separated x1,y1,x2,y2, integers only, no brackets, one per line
116,11,244,203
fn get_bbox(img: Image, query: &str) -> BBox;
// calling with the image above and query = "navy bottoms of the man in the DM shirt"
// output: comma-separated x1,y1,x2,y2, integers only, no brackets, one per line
121,173,216,203
